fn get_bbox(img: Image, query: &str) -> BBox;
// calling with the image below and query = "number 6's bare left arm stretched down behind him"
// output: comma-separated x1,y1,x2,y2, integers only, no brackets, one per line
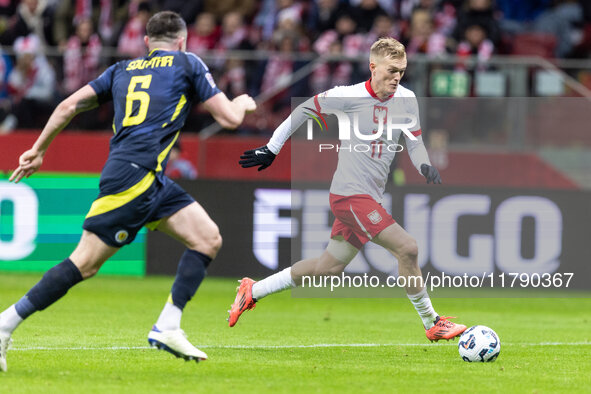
9,85,98,183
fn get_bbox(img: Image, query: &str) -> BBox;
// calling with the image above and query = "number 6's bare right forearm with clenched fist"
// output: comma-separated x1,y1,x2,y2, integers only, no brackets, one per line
203,93,257,129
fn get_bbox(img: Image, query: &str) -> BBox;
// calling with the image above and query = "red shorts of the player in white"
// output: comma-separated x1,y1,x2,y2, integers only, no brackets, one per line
330,193,396,249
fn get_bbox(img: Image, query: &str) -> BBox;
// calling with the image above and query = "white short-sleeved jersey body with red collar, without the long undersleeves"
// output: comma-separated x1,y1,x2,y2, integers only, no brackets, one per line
314,81,421,202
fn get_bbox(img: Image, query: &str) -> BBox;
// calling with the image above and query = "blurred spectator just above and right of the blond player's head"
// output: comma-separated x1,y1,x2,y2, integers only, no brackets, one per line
403,8,447,56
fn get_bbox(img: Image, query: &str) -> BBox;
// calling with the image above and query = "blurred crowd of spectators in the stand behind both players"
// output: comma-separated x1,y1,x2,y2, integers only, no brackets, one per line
0,0,591,133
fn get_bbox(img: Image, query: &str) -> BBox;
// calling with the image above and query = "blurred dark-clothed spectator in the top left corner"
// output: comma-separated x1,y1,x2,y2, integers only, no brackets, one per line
0,0,53,45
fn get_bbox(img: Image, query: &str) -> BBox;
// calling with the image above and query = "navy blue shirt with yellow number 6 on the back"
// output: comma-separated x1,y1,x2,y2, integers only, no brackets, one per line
90,49,220,172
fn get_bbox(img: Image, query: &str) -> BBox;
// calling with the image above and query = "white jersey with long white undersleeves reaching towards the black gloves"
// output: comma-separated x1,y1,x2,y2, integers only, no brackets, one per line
267,80,431,203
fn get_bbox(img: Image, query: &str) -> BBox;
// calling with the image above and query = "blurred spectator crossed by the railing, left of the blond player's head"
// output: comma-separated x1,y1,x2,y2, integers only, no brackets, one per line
310,13,367,92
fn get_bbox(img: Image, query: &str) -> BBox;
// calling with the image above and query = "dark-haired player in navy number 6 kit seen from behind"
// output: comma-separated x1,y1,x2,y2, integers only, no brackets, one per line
0,11,256,371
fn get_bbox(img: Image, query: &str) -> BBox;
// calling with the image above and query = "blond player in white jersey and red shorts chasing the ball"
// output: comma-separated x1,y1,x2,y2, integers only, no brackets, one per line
228,38,466,341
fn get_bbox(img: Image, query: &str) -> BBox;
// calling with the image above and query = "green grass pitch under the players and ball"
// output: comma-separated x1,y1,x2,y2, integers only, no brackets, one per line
0,274,591,394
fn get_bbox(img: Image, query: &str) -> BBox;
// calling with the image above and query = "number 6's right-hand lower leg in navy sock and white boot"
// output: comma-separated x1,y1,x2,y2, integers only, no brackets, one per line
148,250,211,361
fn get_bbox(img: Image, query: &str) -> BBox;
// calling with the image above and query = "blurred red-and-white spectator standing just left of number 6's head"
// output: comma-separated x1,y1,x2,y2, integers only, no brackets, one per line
62,18,102,94
